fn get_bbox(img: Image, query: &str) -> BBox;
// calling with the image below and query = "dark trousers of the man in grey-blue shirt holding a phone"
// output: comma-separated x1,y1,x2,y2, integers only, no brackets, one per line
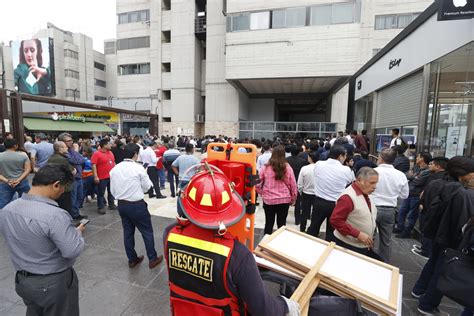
15,268,79,316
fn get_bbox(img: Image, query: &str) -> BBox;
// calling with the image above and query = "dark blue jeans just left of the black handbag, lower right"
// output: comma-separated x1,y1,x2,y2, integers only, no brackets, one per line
413,244,444,311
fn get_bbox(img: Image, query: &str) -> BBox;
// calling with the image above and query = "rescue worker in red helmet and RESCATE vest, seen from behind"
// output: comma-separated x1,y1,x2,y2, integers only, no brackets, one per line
163,164,300,316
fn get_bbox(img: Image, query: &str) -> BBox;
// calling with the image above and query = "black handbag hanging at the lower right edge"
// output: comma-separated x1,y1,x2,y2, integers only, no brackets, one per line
437,248,474,309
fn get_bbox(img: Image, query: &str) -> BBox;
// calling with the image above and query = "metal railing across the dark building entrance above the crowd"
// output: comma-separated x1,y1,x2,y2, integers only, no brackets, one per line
239,121,337,138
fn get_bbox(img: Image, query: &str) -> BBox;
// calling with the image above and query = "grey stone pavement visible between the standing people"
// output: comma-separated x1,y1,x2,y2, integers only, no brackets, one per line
0,183,461,316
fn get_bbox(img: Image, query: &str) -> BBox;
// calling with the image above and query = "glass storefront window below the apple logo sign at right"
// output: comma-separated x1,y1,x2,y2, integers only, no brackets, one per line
422,42,474,158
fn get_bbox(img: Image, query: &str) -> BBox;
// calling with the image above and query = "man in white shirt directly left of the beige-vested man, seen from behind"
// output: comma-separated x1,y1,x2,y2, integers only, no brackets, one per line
308,145,355,241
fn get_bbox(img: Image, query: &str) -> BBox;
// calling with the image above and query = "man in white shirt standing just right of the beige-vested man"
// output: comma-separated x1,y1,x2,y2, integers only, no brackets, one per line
372,149,408,262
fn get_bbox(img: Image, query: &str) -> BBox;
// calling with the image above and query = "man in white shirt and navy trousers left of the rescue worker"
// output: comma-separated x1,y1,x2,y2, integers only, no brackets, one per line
110,143,163,269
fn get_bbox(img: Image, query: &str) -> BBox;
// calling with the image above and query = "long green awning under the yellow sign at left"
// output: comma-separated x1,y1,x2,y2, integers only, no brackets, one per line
23,117,113,132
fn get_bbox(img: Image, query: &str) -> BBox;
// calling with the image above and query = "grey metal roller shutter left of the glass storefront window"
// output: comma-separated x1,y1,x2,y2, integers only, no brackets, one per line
375,71,423,128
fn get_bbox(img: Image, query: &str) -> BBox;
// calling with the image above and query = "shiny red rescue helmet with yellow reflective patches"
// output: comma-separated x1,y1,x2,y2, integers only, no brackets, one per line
178,163,245,229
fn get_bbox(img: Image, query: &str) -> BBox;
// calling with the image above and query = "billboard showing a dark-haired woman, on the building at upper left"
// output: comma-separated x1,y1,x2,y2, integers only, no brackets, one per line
11,37,56,96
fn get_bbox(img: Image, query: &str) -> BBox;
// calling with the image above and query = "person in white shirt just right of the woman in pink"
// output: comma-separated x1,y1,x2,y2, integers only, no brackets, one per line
298,151,319,232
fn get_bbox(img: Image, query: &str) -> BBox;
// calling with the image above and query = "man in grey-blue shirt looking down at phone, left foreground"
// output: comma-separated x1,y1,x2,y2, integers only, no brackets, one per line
0,165,85,316
